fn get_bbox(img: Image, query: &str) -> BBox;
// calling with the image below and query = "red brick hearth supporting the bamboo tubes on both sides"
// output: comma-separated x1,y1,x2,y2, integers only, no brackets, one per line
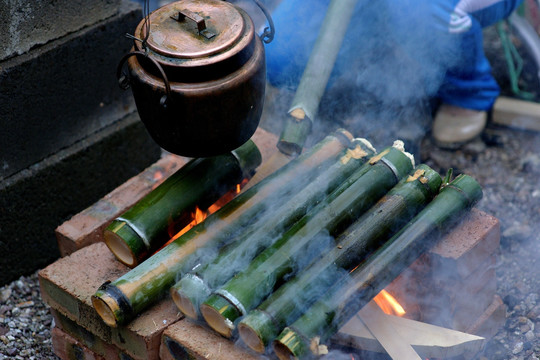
39,130,504,360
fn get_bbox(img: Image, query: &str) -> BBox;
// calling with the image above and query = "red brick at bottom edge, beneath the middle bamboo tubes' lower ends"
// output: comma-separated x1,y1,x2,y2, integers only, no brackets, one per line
160,319,260,360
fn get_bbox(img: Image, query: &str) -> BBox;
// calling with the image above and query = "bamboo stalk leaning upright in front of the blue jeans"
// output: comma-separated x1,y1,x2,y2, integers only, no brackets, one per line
277,0,357,155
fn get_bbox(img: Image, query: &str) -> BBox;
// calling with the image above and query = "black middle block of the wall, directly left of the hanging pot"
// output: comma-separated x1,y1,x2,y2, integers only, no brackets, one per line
0,0,142,181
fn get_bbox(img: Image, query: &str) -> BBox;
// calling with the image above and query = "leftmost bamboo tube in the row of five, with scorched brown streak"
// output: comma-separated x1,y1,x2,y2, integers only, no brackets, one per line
92,130,352,327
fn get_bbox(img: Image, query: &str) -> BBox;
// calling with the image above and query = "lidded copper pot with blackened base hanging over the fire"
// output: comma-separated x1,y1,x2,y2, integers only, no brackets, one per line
118,0,271,157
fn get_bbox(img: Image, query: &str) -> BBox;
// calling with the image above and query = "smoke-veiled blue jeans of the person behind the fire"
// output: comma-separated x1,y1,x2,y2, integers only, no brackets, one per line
266,0,522,110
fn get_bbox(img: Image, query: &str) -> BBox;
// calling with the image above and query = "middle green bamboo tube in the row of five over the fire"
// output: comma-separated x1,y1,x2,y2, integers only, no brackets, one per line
200,143,413,337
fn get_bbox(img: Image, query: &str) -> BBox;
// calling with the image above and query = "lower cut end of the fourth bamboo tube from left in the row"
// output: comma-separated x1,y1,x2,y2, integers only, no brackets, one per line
238,310,279,354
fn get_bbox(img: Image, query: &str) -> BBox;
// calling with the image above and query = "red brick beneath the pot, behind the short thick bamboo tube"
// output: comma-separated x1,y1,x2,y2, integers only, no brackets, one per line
55,155,189,256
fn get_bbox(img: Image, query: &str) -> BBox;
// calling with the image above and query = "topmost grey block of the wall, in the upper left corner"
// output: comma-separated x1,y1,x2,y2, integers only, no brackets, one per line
0,0,120,60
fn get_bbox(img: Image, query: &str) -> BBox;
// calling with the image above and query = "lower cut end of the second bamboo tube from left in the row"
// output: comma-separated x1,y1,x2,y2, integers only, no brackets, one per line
171,274,211,319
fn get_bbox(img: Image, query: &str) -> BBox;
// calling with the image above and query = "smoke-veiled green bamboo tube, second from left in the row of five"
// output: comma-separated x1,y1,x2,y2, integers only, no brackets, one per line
171,139,375,319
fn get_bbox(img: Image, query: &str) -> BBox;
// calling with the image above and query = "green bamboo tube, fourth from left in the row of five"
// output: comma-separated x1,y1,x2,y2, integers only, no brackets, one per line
238,165,442,353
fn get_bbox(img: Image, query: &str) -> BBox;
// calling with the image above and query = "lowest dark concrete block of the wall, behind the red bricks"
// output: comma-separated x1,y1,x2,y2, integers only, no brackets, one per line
0,114,161,284
